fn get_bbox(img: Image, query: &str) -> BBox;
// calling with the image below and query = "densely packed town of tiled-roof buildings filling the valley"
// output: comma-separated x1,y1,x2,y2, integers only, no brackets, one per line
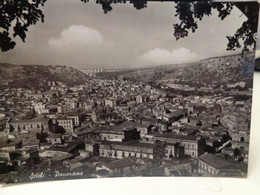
0,53,252,183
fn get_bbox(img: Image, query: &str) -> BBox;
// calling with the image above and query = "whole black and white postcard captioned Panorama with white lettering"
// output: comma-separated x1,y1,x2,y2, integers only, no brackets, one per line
0,0,259,184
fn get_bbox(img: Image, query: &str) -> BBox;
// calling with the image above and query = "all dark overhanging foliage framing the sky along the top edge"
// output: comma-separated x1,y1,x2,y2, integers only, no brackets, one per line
0,0,258,53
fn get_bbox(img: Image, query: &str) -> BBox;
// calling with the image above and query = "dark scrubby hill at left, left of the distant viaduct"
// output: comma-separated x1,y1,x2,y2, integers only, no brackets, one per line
0,63,89,88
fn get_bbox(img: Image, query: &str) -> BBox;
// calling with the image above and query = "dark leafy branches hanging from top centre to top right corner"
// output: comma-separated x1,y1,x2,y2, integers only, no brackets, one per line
81,0,258,53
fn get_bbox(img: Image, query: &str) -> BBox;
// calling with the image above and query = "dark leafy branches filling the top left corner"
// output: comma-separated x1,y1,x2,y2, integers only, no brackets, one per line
0,0,47,52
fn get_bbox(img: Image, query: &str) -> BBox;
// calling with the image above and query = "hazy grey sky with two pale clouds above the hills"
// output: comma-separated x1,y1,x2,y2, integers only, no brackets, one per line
0,0,252,69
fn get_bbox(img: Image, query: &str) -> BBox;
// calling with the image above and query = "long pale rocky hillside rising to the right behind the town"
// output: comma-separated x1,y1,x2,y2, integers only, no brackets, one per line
117,54,254,86
